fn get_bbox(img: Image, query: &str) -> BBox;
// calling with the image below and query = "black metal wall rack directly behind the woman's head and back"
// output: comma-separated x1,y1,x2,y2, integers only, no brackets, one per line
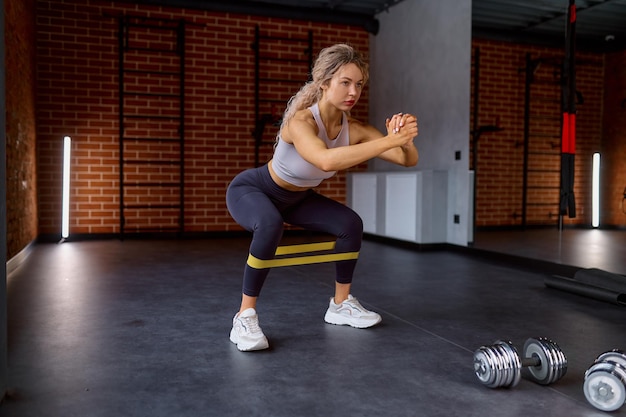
252,25,313,166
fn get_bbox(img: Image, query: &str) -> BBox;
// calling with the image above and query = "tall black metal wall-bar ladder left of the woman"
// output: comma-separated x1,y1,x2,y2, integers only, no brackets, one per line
119,16,185,238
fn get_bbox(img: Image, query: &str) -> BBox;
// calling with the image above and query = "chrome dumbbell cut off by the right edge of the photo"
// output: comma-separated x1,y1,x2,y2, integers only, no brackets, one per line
583,349,626,411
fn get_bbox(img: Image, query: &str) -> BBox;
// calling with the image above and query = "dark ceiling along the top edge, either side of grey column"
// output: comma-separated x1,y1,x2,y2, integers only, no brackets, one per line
128,0,626,52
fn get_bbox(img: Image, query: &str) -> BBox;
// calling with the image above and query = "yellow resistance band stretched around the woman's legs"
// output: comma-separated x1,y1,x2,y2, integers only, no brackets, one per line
247,242,359,269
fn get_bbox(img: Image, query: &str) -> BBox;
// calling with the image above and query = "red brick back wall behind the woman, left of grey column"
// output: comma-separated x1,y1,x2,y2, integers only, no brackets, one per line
37,0,369,235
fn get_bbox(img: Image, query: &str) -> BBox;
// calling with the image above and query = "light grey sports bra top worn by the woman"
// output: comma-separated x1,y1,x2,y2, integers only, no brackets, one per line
272,103,350,187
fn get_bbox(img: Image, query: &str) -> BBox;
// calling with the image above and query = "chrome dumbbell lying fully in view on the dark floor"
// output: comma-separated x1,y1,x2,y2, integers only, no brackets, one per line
474,337,567,388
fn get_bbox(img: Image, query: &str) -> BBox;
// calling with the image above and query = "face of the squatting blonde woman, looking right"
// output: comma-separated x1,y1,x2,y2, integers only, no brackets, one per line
322,63,365,111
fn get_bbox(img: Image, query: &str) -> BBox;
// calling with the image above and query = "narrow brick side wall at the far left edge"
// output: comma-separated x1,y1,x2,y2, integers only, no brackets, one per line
4,0,37,259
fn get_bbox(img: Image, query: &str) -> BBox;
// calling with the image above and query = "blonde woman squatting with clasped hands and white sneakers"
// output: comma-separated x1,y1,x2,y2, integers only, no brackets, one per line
226,44,418,351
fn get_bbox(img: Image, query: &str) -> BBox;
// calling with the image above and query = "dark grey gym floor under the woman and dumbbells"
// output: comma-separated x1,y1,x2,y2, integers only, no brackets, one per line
0,230,626,417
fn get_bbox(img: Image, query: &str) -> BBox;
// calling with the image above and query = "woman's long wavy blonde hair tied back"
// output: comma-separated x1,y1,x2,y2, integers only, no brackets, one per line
279,43,369,131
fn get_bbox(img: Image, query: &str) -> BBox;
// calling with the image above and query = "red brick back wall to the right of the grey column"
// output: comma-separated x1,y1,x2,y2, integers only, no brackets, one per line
472,39,604,227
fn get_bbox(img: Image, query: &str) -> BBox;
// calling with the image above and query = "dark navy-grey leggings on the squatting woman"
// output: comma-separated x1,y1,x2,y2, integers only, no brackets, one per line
226,165,363,297
